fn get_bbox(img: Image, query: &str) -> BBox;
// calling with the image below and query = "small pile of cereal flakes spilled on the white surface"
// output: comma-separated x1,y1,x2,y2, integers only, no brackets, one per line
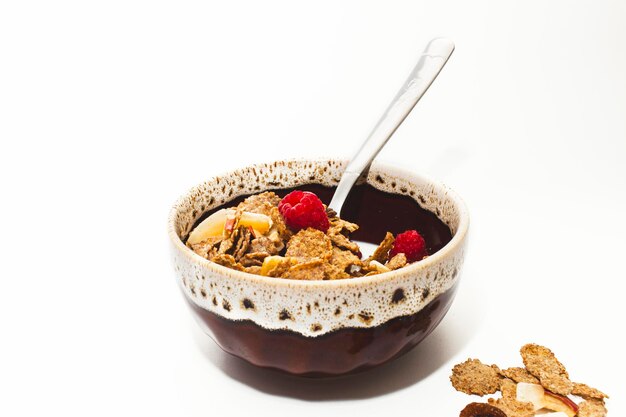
450,343,609,417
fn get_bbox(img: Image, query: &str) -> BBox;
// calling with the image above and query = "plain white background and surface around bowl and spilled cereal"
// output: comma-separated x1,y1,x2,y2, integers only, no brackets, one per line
0,0,626,417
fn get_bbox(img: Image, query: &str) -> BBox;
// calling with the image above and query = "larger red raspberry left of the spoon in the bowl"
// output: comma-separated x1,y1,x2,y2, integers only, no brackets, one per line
278,190,330,233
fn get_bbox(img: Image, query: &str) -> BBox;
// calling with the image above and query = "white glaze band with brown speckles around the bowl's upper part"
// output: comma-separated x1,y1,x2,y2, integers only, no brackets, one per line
168,160,469,337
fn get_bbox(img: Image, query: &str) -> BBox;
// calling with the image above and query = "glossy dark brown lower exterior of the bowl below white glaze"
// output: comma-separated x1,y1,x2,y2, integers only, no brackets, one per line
187,285,457,377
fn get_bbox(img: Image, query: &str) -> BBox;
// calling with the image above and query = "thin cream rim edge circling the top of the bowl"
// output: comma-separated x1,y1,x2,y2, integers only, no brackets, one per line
167,158,469,290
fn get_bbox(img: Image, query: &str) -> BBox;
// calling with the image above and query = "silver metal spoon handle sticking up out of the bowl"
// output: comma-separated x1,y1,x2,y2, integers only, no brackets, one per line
328,38,454,214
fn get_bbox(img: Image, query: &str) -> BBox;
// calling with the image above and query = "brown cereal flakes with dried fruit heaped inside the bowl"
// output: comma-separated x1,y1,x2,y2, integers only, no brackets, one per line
187,191,420,280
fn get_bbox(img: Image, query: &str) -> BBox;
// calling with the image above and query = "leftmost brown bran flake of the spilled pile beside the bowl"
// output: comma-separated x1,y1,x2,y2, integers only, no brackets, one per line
450,359,501,396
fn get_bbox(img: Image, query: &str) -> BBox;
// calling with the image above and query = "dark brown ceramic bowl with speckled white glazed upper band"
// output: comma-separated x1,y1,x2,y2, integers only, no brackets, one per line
168,160,469,376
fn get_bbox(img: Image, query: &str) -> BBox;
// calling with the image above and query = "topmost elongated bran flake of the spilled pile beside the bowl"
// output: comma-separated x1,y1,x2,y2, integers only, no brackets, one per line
520,343,572,395
